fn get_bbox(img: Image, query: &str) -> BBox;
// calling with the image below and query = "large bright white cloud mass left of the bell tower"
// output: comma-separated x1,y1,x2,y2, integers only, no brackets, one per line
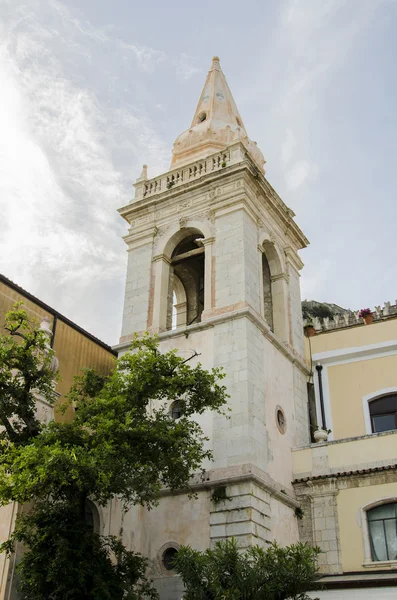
0,1,169,342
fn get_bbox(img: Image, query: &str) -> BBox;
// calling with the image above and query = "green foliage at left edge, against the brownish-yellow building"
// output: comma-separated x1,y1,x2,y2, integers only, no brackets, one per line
0,303,55,444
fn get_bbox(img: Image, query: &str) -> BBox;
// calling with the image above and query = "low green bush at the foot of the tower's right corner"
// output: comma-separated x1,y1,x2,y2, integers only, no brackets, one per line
175,539,320,600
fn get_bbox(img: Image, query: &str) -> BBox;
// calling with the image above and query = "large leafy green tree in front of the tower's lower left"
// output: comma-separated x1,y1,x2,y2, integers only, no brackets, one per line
0,308,226,600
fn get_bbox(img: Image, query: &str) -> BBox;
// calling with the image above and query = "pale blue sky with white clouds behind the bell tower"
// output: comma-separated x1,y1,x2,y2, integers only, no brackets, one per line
0,0,397,344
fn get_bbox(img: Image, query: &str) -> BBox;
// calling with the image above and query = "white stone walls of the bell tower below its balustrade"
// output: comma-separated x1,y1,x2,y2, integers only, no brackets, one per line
116,145,309,600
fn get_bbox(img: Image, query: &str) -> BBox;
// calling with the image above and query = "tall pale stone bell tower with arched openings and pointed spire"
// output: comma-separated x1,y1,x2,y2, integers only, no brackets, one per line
119,57,309,600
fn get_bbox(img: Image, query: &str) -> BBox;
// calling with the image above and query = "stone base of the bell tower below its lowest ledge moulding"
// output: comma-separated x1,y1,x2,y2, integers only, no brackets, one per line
103,464,299,600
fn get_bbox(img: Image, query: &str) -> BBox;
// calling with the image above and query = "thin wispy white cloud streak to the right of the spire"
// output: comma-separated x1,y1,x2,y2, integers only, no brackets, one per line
266,0,383,193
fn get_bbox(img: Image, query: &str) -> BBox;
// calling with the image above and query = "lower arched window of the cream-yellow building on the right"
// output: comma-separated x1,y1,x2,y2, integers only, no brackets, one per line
367,502,397,562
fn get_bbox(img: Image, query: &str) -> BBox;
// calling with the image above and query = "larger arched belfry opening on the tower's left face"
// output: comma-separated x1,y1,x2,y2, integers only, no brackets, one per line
167,233,205,329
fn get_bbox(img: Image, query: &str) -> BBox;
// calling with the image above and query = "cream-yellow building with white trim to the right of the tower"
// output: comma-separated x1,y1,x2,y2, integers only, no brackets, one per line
292,303,397,600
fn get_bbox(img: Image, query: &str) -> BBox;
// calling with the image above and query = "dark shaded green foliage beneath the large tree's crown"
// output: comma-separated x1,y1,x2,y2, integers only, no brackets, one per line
2,502,158,600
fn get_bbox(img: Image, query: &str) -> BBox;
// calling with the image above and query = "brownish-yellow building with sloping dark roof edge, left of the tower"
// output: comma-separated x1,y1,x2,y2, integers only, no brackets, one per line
0,275,116,600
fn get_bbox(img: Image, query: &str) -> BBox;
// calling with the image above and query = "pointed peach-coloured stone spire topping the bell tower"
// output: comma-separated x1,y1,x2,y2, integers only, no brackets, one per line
171,56,265,172
